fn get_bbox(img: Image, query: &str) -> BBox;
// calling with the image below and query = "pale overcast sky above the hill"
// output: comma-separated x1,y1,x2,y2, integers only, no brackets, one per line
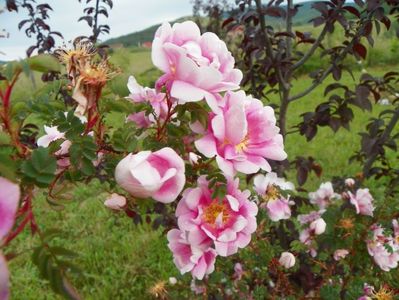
0,0,310,60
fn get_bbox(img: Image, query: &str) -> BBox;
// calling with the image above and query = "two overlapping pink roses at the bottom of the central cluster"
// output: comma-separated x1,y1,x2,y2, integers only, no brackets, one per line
168,176,258,279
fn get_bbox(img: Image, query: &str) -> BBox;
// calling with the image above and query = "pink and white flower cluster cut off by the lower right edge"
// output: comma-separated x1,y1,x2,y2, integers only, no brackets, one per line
366,220,399,272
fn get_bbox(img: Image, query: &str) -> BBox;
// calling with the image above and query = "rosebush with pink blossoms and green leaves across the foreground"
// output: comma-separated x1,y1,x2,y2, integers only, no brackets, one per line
0,15,399,299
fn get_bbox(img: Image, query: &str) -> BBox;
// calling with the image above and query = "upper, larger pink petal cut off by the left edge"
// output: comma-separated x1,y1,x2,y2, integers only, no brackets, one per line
0,177,20,241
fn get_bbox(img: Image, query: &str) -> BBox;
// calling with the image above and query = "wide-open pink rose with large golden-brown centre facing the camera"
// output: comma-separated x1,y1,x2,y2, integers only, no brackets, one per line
176,176,258,256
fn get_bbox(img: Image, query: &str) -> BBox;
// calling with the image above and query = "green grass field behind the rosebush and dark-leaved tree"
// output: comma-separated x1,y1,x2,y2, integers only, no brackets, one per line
10,49,399,299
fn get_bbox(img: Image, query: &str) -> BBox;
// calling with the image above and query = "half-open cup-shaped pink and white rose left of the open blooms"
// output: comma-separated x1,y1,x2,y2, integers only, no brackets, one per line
115,147,186,203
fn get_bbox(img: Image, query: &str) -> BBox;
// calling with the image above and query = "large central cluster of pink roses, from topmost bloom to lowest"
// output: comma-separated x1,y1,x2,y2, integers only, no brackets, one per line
113,21,293,279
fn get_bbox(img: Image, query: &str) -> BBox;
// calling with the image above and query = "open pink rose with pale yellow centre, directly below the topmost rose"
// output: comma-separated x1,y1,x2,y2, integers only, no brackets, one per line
195,91,287,176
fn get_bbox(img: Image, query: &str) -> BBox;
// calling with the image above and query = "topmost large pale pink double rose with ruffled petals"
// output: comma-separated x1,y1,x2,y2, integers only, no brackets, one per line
152,21,242,110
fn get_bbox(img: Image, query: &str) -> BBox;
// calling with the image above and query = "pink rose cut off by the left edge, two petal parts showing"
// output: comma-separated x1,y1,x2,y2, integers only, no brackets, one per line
0,177,20,300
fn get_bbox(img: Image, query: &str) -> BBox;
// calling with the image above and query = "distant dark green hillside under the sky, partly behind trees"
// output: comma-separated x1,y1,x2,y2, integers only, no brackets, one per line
104,1,344,47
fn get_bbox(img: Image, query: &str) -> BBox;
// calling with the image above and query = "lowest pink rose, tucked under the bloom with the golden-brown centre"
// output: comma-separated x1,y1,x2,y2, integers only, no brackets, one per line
167,229,216,280
